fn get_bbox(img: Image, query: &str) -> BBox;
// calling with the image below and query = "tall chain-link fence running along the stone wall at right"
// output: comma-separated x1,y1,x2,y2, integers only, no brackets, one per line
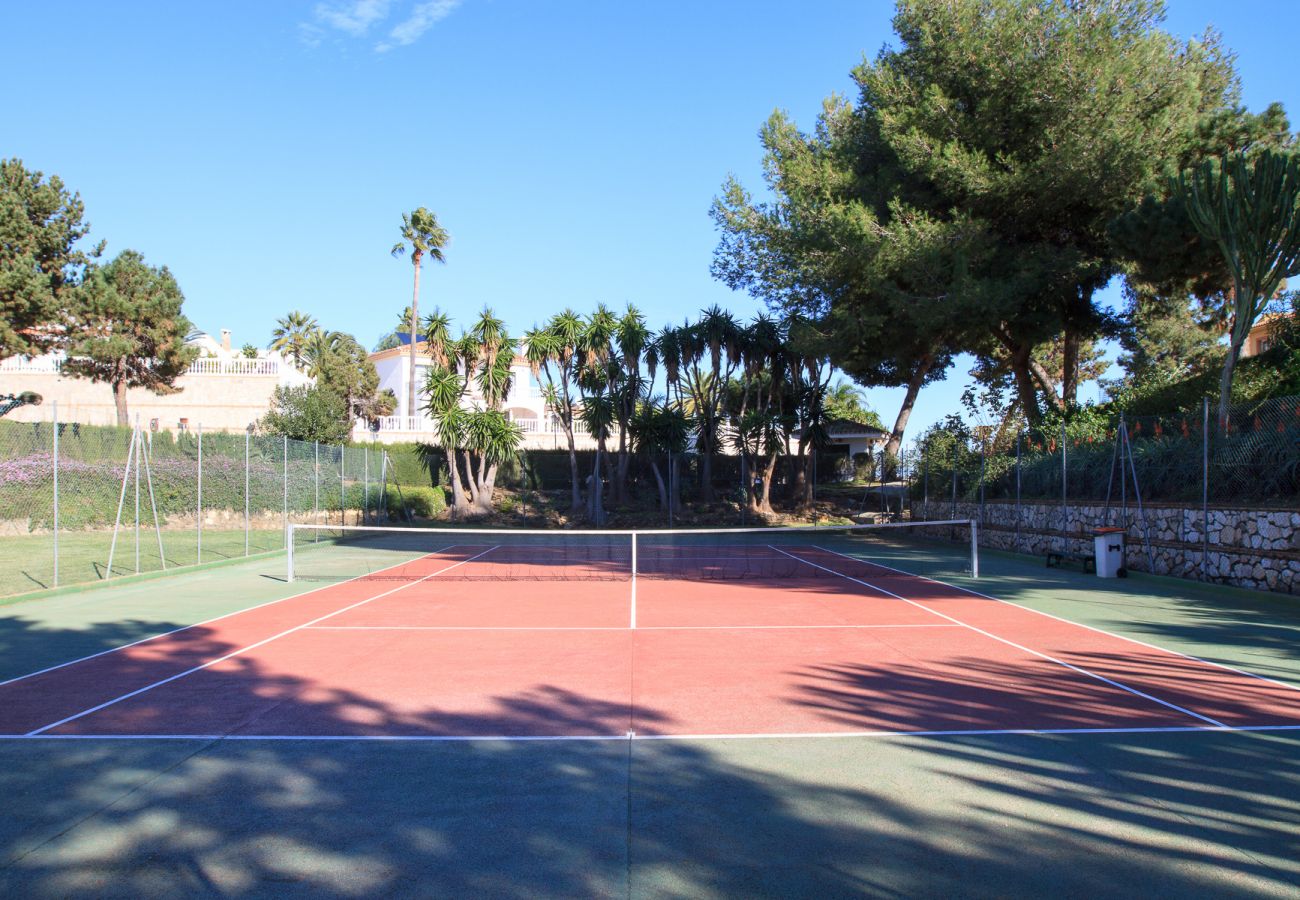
909,398,1300,589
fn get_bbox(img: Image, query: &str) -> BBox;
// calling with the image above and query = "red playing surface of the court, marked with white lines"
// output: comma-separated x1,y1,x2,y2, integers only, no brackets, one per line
0,546,1300,740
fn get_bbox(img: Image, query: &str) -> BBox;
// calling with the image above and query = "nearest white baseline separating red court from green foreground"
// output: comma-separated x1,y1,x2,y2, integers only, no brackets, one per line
0,724,1300,743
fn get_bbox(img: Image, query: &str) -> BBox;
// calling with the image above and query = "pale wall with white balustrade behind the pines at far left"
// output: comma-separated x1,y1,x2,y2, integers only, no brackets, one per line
0,329,312,432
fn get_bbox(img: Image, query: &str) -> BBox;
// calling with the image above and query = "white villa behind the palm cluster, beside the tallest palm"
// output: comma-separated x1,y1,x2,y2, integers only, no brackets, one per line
352,345,595,450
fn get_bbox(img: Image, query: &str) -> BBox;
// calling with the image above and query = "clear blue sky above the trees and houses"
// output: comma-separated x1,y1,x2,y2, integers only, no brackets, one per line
0,0,1300,434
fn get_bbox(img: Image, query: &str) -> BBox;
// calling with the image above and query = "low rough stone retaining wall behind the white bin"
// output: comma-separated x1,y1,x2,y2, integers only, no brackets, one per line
913,501,1300,594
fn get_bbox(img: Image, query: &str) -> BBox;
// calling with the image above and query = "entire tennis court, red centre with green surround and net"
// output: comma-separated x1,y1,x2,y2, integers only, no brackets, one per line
0,523,1300,896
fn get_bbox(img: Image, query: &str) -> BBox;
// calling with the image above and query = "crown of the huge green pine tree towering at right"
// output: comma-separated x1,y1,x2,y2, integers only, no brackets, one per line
714,0,1290,451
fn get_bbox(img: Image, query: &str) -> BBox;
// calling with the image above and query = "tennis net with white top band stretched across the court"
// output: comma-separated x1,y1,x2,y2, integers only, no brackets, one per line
287,520,979,581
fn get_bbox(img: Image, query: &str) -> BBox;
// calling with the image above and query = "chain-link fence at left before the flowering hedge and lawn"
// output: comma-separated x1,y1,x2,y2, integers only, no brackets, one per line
0,411,395,597
